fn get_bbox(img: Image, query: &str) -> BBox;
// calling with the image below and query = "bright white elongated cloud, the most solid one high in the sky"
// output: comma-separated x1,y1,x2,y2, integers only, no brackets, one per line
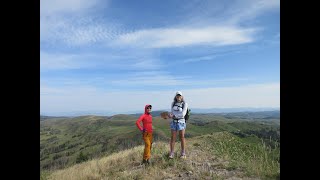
116,26,257,48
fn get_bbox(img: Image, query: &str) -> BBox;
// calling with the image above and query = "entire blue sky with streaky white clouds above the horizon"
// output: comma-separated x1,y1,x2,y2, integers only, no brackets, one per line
40,0,280,115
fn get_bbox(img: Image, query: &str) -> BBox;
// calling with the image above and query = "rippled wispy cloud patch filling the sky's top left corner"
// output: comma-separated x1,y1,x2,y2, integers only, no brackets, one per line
40,0,121,46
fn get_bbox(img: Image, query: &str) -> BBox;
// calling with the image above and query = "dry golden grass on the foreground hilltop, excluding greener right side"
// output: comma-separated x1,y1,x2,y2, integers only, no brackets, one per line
48,133,276,180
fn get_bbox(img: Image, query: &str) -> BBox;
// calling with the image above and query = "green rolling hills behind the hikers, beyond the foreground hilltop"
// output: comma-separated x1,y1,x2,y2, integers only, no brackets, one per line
40,111,280,177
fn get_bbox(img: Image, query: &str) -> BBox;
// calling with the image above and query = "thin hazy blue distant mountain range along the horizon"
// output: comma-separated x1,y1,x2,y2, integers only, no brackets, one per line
41,107,280,117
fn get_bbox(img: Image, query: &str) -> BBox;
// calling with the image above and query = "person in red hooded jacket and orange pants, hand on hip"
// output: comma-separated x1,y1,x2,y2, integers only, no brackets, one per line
136,104,152,164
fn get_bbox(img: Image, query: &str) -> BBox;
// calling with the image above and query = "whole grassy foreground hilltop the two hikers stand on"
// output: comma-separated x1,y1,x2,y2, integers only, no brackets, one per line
42,132,280,180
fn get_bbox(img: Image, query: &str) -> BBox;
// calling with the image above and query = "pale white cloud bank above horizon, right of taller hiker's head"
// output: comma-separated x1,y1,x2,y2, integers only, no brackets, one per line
184,83,280,108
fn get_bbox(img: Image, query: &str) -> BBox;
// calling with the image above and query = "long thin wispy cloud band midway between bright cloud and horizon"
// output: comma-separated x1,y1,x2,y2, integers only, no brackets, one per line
41,69,254,89
